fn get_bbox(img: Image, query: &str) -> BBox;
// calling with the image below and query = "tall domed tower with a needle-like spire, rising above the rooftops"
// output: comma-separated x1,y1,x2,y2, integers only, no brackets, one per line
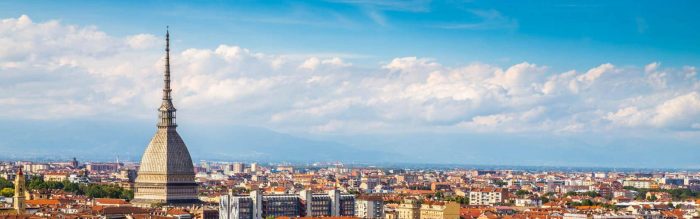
132,28,199,206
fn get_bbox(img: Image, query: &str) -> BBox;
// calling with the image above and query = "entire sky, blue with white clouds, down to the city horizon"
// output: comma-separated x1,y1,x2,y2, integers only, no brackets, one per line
0,0,700,168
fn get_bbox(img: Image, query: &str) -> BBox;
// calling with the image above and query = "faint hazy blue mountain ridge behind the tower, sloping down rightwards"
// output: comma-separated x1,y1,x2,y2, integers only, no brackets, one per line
0,118,392,162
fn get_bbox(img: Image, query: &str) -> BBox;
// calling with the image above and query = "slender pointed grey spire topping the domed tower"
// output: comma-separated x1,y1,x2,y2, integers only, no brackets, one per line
158,26,177,128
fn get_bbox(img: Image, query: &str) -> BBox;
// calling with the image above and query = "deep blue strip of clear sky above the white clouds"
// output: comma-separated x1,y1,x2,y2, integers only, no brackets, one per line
5,0,700,70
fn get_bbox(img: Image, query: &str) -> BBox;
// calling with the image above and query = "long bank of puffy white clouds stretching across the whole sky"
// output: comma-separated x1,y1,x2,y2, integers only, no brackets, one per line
0,16,700,136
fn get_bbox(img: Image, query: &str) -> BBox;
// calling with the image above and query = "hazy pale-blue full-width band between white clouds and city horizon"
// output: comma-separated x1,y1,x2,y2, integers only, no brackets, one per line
0,120,700,168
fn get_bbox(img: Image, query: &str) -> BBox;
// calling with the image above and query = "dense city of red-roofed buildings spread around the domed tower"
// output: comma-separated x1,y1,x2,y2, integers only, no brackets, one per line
0,160,700,219
